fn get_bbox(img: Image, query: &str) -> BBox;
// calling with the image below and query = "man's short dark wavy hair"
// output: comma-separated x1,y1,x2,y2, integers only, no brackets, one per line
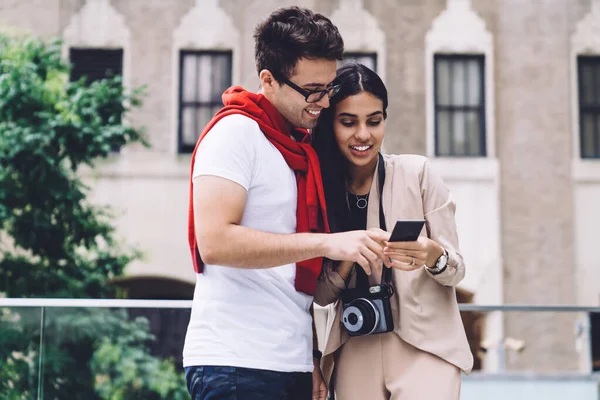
254,7,344,79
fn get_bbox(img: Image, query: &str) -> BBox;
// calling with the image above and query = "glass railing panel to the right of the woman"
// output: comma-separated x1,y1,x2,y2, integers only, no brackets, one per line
460,304,600,400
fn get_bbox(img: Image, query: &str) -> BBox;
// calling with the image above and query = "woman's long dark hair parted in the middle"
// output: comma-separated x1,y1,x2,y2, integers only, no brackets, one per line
312,63,388,232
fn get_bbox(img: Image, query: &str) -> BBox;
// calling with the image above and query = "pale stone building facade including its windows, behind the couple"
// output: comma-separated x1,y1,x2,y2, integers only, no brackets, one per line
0,0,600,372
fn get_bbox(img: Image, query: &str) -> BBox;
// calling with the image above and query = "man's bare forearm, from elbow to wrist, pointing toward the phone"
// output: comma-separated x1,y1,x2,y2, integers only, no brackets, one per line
197,224,326,269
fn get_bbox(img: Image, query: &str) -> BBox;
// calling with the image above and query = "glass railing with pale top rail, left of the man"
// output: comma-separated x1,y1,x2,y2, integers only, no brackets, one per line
0,299,191,400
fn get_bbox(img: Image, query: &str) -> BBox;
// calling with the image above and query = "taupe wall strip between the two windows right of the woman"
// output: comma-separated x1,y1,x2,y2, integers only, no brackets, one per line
496,1,577,370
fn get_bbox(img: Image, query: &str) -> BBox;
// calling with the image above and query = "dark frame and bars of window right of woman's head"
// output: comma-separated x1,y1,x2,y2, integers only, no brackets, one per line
433,53,488,159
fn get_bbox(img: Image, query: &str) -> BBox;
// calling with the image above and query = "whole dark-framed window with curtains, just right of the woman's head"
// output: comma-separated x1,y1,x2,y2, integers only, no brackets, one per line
434,54,486,157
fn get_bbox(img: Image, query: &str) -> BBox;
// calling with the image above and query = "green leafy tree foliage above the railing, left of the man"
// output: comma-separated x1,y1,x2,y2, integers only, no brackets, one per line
0,36,144,297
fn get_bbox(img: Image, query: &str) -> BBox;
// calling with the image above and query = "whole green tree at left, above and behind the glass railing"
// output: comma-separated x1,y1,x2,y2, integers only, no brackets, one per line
0,34,186,400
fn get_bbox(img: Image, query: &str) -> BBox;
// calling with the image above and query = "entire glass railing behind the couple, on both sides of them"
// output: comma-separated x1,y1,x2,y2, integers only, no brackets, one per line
0,298,600,400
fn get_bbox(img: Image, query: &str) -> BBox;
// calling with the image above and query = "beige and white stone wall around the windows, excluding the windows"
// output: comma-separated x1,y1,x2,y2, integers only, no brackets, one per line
0,0,600,376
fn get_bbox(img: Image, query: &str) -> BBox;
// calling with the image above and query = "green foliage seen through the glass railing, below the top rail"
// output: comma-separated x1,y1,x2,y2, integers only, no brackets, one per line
0,308,187,400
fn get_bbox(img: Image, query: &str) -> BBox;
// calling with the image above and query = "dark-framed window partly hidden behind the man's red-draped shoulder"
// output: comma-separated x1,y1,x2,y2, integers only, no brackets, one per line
178,51,232,153
